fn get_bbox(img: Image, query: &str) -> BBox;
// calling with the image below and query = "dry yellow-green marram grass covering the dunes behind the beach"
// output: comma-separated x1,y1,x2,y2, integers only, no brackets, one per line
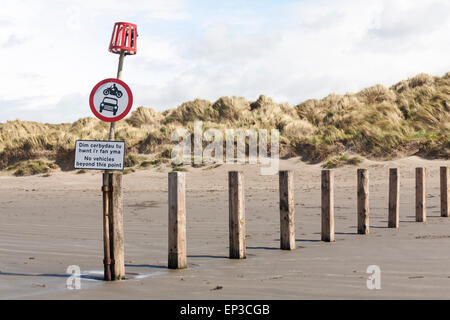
0,73,450,175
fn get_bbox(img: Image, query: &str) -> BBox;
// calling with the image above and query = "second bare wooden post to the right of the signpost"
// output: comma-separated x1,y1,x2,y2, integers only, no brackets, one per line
228,171,245,259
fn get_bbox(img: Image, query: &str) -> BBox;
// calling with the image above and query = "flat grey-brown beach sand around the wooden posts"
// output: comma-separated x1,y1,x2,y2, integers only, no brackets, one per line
0,157,450,299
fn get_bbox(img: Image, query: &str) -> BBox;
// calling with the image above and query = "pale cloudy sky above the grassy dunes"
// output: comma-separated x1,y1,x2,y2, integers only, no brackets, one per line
0,0,450,123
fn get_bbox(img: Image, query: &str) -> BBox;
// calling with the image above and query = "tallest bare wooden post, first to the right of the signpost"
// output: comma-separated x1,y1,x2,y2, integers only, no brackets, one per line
168,171,187,269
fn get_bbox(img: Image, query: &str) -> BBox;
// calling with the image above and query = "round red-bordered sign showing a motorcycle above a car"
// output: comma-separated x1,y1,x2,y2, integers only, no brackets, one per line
89,78,133,122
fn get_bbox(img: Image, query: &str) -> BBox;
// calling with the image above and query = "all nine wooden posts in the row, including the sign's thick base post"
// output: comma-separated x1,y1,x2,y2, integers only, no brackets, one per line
103,167,449,280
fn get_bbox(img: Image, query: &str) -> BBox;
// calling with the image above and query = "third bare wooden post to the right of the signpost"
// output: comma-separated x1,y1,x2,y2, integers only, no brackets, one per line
279,171,295,250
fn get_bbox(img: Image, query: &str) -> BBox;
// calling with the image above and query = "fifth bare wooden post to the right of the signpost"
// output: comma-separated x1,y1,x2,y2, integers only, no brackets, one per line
357,169,370,234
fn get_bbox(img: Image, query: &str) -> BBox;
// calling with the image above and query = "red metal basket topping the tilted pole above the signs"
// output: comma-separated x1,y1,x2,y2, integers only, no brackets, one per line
109,22,138,55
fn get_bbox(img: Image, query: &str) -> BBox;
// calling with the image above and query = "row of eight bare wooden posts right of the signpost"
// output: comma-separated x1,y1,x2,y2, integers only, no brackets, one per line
168,167,449,269
